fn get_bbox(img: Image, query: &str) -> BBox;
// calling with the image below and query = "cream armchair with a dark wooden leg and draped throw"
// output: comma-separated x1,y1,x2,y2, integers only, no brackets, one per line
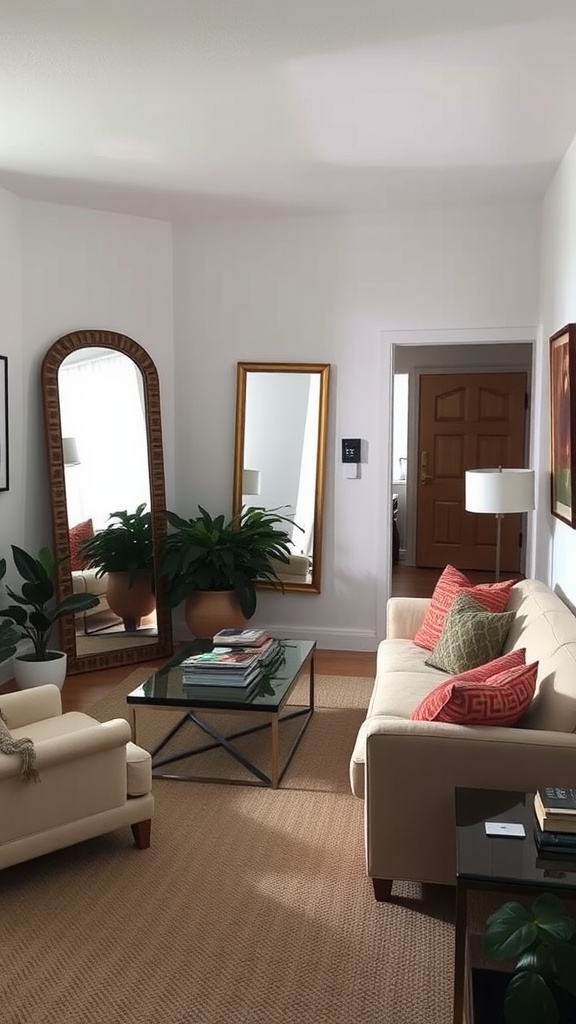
0,685,154,868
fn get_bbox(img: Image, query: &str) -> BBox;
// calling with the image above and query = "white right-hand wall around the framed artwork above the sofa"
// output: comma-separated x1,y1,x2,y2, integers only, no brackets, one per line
537,132,576,605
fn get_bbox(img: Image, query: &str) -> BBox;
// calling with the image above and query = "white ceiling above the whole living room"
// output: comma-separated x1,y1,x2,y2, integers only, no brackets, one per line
0,0,576,219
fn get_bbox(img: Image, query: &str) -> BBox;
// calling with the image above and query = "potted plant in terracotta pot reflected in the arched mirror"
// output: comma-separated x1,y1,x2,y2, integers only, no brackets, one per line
80,502,156,630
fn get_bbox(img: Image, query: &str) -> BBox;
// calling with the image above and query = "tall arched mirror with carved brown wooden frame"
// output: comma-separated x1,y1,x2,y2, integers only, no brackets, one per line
43,331,171,671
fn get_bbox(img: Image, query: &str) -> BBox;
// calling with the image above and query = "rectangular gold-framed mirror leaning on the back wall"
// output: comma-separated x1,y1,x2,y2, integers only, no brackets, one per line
228,362,330,594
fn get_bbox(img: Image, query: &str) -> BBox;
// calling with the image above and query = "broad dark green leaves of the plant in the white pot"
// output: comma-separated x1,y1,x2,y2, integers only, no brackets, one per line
0,544,98,662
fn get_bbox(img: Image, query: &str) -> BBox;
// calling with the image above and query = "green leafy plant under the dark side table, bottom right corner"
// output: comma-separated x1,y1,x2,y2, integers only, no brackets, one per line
484,893,576,1024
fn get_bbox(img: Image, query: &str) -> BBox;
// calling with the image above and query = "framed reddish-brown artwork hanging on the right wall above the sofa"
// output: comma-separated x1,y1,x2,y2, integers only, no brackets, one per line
550,324,576,529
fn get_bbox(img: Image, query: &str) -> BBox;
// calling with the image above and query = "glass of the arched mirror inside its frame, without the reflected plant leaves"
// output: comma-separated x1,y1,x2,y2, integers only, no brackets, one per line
58,347,158,655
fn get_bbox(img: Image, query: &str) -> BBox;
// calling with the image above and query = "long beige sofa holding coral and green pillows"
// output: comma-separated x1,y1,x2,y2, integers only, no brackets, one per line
351,580,576,899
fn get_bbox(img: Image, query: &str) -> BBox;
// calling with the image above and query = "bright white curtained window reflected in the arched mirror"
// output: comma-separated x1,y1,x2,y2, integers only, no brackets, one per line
58,353,150,529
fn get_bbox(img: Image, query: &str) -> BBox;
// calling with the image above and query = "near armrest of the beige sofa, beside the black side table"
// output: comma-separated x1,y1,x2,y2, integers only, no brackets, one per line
365,717,576,885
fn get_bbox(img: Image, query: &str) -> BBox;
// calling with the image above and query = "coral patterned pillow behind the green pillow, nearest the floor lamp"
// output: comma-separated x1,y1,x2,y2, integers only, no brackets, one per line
414,565,515,650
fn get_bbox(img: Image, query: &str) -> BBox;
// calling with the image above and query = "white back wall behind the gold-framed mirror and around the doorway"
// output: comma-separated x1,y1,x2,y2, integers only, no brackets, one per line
174,205,540,649
